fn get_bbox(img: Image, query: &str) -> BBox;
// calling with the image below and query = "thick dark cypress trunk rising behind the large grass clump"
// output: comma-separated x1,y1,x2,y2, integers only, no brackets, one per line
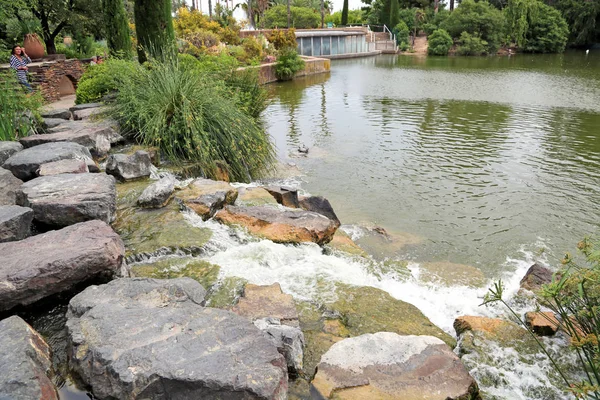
134,0,175,63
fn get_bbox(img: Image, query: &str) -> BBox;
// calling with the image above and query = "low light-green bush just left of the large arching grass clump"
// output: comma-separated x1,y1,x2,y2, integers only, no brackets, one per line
75,58,137,104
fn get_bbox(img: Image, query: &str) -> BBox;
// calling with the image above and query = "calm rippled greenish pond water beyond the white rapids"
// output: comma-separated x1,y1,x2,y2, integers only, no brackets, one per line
265,52,600,277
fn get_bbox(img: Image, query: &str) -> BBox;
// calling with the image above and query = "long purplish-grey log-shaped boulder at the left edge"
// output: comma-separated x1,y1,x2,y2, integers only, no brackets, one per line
0,221,125,311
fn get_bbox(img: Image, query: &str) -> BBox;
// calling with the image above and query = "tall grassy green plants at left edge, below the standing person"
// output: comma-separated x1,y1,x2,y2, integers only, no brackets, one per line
0,71,42,141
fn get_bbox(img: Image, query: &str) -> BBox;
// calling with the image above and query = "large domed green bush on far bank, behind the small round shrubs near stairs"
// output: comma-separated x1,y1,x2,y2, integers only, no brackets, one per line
442,0,506,53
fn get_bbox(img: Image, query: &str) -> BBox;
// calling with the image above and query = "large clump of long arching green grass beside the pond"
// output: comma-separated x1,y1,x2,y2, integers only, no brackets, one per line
113,59,275,182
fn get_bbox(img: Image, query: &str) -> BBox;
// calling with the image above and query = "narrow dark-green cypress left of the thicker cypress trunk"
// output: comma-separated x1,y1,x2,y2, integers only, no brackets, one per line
102,0,133,59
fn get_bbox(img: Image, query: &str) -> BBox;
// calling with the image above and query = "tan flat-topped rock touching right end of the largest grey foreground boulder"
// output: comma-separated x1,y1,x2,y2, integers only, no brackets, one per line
232,283,298,327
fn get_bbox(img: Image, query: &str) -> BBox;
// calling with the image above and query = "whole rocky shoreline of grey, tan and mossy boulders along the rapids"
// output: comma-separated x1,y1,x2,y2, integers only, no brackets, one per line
0,104,572,400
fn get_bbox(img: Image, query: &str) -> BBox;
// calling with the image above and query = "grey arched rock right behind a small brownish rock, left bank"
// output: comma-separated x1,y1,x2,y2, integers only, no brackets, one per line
3,142,100,181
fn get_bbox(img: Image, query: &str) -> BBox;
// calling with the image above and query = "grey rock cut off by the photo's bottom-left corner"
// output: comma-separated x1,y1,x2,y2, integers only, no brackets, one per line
0,315,59,400
